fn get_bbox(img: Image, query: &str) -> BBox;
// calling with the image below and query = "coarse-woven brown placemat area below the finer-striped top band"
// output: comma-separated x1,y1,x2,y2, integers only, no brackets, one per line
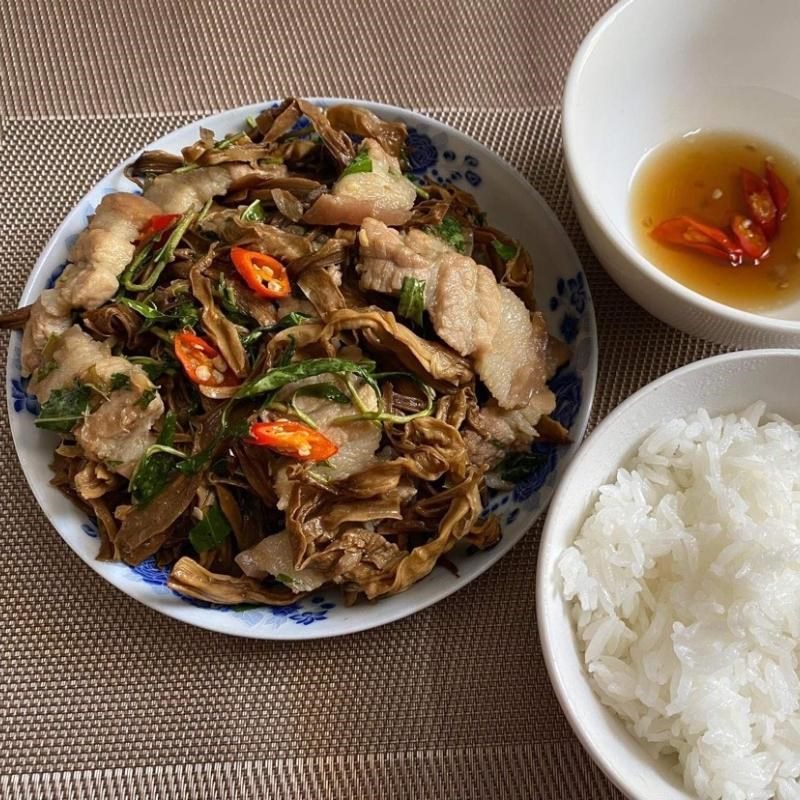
0,109,732,798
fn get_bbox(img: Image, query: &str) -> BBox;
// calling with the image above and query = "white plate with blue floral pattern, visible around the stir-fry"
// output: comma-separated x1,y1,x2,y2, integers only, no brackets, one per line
8,99,597,639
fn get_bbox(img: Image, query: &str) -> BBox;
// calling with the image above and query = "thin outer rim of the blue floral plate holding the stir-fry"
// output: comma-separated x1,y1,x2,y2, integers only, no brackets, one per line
6,96,599,641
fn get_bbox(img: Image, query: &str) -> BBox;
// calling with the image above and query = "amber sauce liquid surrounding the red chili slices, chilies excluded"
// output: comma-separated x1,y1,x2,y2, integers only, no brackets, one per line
631,132,800,311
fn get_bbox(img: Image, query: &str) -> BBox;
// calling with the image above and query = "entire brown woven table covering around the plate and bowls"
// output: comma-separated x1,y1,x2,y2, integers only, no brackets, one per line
0,0,716,800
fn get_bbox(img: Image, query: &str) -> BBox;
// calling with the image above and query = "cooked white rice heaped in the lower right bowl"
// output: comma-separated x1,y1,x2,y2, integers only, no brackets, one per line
559,403,800,800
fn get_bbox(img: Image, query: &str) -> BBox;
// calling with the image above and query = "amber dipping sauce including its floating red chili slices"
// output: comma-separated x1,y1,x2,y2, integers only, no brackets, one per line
631,130,800,319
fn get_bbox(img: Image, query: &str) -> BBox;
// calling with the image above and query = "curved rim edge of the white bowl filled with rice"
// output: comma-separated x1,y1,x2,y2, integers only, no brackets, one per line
535,347,800,800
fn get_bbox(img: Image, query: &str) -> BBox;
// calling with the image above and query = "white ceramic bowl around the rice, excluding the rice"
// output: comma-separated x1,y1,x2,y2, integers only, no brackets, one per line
536,349,800,800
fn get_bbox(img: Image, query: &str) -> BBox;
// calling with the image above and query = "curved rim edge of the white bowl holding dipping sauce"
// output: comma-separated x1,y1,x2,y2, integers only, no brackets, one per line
561,0,800,334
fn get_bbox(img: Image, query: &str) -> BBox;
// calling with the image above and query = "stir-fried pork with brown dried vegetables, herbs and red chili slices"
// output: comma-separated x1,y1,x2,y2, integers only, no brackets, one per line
2,99,567,604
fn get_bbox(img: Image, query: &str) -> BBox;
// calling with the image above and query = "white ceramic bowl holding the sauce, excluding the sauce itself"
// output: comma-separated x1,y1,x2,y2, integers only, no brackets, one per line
563,0,800,347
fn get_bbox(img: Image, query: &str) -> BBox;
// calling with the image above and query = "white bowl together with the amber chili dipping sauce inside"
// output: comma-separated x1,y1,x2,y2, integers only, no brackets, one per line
563,0,800,347
